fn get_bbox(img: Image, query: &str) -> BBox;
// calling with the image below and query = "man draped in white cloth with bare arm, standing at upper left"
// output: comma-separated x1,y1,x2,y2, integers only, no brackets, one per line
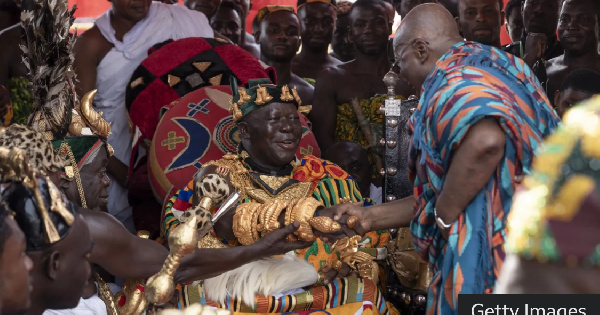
75,0,214,232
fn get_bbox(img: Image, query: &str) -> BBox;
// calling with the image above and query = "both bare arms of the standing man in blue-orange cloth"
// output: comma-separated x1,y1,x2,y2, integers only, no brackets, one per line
328,119,506,241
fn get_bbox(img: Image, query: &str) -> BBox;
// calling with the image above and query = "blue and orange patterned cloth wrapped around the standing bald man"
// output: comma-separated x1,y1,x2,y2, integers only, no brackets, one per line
409,42,558,315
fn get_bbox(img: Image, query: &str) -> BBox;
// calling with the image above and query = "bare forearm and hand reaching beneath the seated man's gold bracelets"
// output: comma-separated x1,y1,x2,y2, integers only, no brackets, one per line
175,222,312,283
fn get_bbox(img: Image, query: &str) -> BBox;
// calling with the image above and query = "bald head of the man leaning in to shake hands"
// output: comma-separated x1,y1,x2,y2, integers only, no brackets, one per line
394,3,462,89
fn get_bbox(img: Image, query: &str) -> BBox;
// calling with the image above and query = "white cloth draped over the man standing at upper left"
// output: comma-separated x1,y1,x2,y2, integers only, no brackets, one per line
94,2,214,231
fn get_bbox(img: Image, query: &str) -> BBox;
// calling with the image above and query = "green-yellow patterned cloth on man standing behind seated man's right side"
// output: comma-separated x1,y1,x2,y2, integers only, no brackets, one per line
335,95,402,177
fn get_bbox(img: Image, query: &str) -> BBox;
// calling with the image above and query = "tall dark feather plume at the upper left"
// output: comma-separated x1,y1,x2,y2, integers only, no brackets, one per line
21,0,78,139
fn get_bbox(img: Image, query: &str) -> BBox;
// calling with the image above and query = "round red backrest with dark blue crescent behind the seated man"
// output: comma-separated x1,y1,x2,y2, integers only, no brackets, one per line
148,86,322,202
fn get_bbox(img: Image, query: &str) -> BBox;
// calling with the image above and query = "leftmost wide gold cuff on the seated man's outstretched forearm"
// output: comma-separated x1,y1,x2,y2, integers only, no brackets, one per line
233,202,261,245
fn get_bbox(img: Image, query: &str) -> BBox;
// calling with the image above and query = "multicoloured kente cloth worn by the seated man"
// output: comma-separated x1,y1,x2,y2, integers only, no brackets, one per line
163,155,395,314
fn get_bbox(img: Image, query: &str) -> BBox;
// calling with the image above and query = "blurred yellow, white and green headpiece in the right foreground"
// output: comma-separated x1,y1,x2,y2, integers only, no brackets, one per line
506,96,600,268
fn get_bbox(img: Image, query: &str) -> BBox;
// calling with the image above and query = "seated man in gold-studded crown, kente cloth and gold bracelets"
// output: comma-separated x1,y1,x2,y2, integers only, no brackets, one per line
162,79,397,314
